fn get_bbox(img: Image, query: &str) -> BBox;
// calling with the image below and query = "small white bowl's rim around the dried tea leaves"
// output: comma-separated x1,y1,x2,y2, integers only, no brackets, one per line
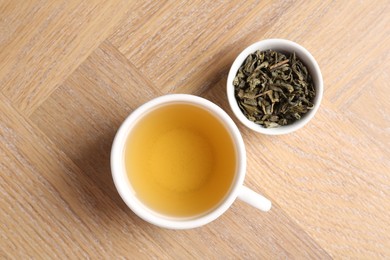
227,39,324,135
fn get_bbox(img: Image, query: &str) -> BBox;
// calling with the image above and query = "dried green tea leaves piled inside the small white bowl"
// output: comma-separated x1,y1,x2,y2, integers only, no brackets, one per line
233,50,315,128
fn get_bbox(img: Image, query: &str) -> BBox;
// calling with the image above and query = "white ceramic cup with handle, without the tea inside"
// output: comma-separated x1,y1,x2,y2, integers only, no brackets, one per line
111,94,271,229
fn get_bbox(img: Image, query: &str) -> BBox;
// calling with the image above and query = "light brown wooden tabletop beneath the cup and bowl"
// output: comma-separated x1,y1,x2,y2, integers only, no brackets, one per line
0,0,390,259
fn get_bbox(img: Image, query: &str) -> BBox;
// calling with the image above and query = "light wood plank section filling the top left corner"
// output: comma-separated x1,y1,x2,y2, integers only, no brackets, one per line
0,0,130,115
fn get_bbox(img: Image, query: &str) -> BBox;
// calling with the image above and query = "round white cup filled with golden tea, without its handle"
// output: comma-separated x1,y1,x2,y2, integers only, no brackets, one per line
111,94,245,229
